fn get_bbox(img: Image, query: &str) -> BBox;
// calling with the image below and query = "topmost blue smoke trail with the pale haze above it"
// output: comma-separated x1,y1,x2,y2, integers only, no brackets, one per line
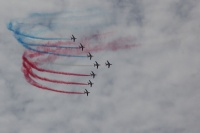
7,8,111,37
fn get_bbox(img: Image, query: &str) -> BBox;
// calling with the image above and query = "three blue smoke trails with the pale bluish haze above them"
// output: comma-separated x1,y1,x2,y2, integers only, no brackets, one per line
7,8,111,57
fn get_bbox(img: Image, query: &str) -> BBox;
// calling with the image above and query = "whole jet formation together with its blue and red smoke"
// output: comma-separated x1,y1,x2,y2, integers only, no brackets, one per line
7,14,137,96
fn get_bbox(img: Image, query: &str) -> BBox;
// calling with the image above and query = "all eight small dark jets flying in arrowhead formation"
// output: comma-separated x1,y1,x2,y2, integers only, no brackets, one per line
71,35,112,96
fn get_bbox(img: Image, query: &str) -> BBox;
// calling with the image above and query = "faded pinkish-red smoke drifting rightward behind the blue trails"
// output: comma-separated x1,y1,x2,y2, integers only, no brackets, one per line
23,33,137,63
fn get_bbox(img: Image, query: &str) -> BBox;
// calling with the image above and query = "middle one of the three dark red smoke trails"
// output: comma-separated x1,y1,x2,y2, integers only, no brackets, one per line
23,62,88,85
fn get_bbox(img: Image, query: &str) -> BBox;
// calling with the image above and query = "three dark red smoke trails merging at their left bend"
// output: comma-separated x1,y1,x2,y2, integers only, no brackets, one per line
22,50,90,94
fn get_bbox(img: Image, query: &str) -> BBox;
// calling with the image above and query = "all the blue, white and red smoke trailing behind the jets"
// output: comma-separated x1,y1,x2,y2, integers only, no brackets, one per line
7,8,136,94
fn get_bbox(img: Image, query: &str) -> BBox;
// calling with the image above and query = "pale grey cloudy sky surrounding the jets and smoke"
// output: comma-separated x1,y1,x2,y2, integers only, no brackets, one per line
0,0,200,133
